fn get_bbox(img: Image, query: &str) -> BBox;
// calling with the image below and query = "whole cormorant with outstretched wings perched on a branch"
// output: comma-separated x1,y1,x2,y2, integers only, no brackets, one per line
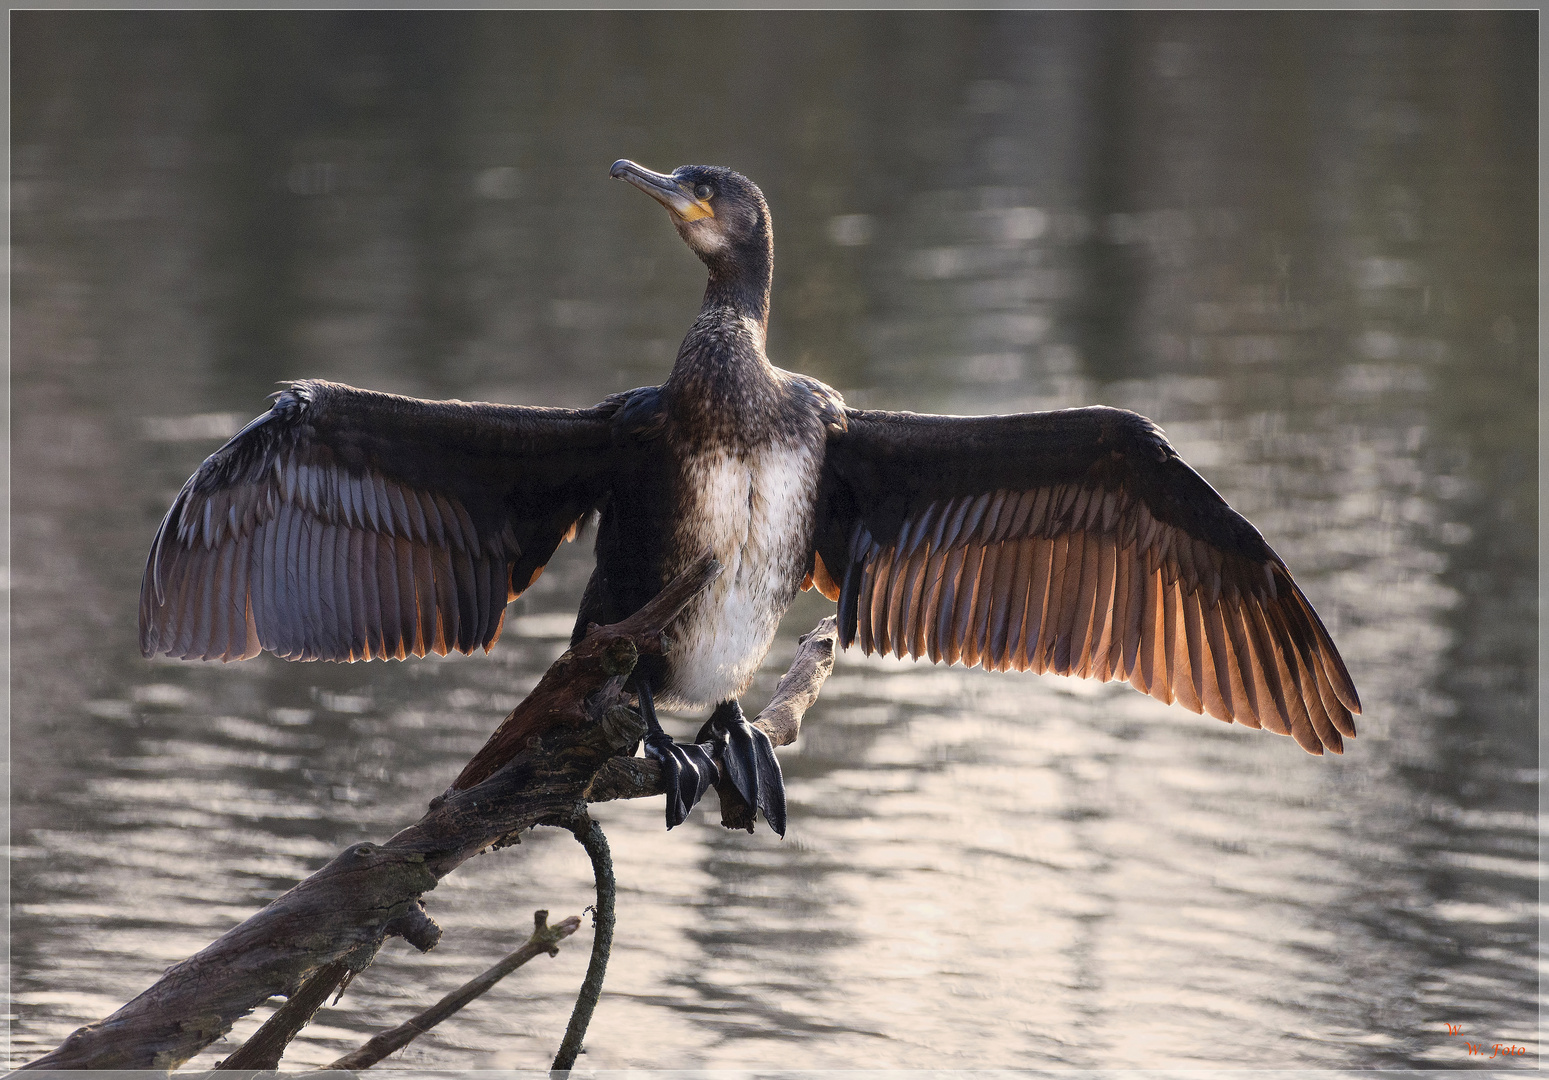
139,161,1360,835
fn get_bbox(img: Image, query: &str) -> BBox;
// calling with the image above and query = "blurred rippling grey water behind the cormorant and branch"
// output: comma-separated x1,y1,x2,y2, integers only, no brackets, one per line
11,11,1543,1068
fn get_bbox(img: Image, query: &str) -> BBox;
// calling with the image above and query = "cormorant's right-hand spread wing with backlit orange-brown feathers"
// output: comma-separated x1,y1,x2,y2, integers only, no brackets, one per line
815,409,1360,753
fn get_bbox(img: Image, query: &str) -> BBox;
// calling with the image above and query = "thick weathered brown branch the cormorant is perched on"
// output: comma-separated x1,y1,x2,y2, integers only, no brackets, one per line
22,555,833,1069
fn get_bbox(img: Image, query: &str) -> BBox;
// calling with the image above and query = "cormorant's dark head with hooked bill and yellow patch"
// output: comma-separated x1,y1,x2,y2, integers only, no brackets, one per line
609,158,773,271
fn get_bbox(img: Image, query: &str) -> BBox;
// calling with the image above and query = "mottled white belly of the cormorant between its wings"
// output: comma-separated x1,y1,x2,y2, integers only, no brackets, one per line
661,443,821,708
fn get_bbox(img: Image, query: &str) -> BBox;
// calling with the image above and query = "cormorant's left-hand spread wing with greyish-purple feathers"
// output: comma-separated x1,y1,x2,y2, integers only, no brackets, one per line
139,381,617,660
